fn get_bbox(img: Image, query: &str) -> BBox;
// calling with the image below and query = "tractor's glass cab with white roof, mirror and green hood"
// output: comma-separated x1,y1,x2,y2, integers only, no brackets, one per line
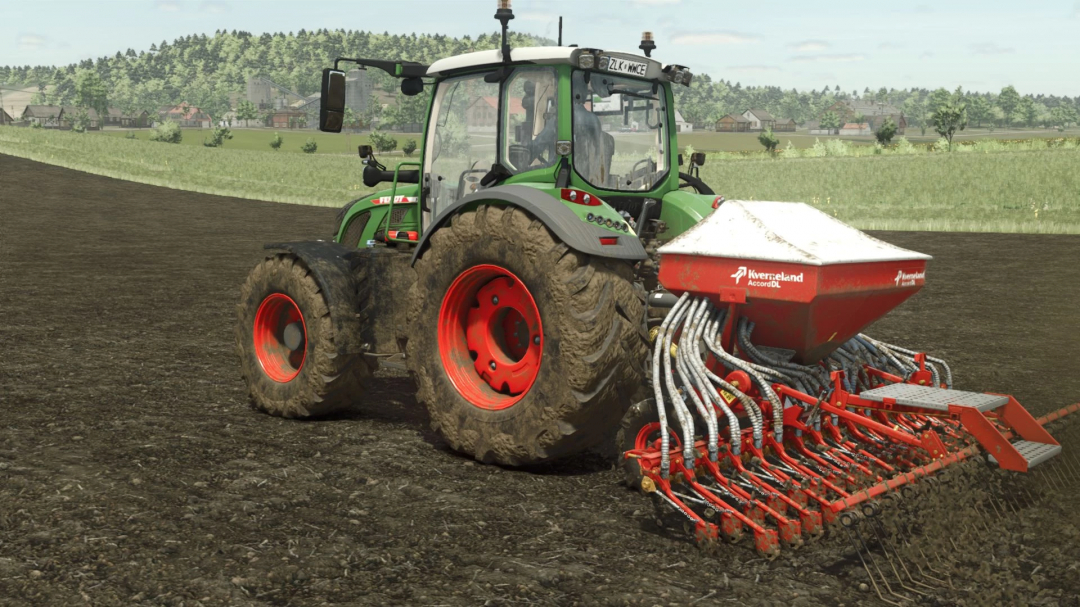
320,2,714,247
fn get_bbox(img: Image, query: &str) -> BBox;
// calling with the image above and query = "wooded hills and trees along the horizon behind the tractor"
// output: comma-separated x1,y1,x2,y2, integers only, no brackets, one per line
0,29,1080,127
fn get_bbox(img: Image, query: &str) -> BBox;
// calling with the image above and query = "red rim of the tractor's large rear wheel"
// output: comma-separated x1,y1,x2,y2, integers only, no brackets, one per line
438,265,543,410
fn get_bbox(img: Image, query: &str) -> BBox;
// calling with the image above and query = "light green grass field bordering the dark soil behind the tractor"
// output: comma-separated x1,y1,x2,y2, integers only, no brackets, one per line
0,126,1080,233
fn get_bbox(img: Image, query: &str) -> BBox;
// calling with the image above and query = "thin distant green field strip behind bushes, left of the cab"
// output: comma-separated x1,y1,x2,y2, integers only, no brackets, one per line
99,129,423,156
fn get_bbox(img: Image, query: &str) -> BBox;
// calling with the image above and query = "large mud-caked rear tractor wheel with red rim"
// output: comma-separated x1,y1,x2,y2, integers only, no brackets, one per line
406,206,647,466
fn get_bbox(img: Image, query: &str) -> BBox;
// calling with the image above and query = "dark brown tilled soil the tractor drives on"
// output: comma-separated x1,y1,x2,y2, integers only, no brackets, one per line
0,157,1080,606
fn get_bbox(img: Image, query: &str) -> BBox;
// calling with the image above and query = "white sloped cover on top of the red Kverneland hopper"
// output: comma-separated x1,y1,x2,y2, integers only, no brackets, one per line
660,200,931,266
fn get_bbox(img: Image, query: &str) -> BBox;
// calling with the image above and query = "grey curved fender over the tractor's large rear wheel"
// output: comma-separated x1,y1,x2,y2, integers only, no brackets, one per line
413,186,647,264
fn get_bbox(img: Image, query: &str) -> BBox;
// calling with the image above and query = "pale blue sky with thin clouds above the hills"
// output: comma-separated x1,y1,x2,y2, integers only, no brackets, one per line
0,0,1080,95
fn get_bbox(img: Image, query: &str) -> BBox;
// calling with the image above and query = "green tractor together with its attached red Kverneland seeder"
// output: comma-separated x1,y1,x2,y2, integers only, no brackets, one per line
235,0,1071,574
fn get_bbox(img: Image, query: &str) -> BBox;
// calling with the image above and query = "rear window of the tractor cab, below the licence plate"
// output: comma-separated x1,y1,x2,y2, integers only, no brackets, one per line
572,71,667,191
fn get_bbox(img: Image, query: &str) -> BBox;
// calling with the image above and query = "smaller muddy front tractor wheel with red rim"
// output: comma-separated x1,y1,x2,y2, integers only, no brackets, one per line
235,254,370,418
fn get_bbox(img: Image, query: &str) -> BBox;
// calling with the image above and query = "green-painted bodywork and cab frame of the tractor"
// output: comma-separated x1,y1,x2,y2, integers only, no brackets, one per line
335,65,714,246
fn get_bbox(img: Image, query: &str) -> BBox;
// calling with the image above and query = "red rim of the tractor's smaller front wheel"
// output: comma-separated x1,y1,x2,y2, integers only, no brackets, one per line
253,293,308,383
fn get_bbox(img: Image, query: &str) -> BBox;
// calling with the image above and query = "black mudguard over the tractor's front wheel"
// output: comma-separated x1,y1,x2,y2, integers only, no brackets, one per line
264,240,367,354
